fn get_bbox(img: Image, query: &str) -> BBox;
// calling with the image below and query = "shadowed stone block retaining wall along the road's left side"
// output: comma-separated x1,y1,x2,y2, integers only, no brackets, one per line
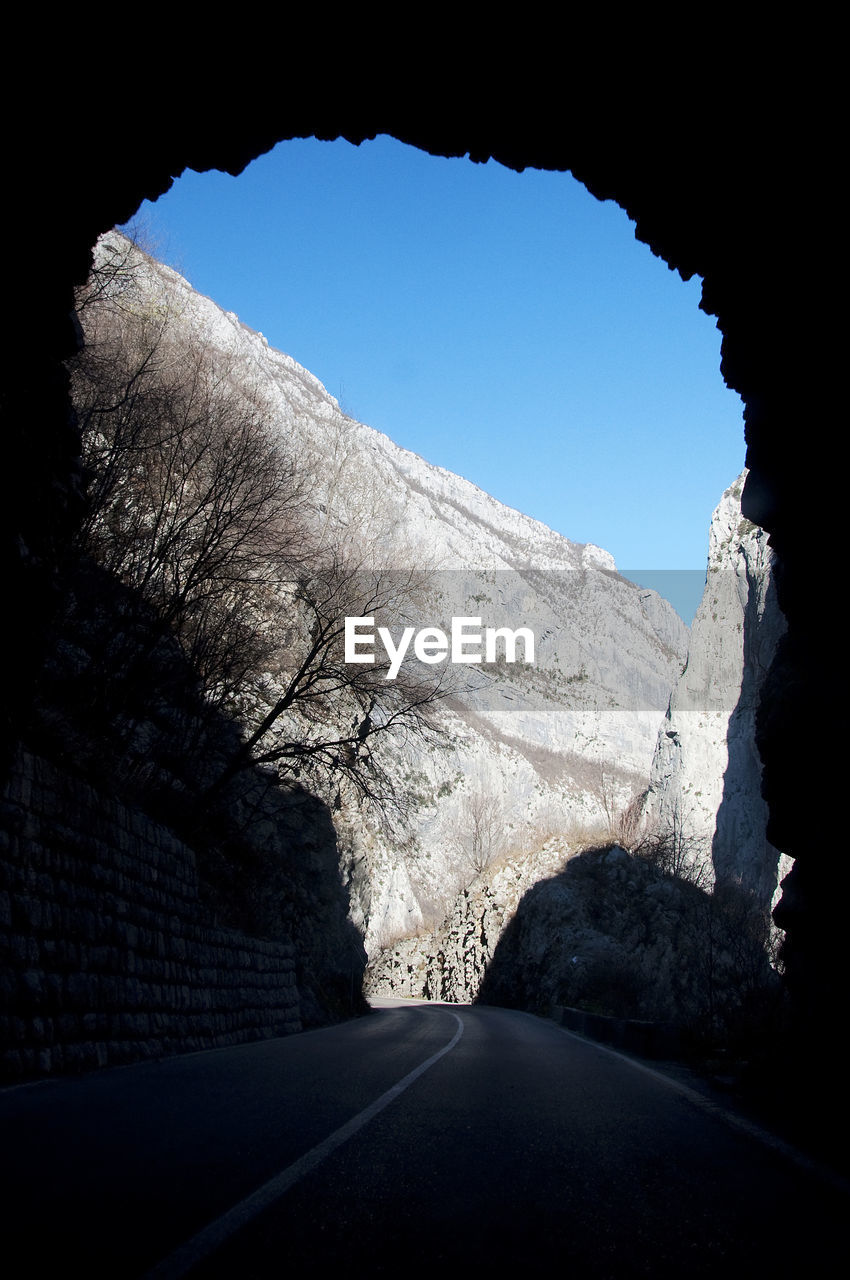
0,753,301,1082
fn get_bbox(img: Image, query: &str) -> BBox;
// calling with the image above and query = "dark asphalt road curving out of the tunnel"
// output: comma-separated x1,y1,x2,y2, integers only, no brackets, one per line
0,1001,850,1280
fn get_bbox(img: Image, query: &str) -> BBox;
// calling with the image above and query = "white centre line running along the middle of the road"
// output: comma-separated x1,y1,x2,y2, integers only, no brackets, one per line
146,1014,463,1280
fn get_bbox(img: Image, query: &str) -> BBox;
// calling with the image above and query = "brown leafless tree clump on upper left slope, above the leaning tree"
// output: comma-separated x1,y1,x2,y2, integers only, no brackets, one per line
73,273,306,705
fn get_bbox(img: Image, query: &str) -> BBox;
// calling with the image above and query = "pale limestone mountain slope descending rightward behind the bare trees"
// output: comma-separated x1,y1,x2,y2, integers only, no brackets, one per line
89,233,687,954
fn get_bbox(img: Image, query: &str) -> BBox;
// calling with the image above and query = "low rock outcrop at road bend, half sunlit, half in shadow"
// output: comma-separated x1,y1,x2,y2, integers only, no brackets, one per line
366,841,781,1042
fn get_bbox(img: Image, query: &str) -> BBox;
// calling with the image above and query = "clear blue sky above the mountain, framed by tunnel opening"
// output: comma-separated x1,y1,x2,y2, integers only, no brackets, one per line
131,138,744,616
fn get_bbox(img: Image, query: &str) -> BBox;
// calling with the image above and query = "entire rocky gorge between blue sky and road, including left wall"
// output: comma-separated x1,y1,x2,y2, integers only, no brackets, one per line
3,233,783,1079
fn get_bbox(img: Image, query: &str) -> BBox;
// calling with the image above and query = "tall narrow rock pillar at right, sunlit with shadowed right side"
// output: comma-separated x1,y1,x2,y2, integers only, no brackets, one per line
646,472,785,909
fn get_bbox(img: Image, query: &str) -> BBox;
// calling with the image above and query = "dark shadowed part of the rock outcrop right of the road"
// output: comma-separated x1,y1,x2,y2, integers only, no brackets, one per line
477,845,780,1044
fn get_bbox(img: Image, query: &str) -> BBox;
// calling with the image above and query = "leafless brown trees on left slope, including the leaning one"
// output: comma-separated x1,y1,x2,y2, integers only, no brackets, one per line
72,234,442,806
